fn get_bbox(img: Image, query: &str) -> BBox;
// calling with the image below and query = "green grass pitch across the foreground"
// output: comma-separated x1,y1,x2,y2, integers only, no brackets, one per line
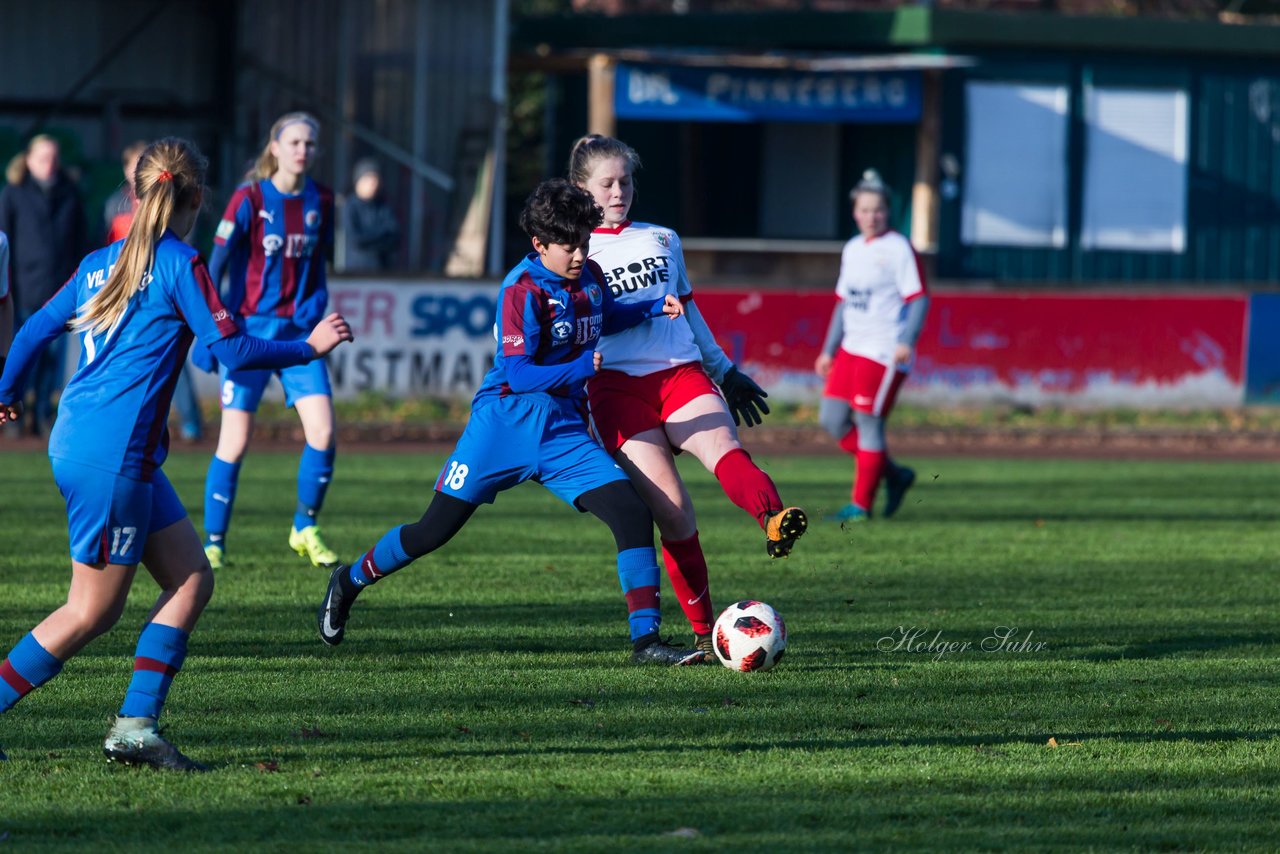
0,452,1280,853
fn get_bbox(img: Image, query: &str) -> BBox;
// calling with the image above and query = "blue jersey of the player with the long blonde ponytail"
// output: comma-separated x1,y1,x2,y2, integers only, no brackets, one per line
23,232,238,480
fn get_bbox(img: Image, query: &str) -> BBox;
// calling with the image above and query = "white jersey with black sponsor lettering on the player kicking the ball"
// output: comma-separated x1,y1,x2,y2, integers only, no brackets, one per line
590,222,703,376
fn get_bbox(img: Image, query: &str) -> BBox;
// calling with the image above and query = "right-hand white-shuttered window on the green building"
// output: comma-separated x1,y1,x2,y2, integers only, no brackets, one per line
1080,87,1188,252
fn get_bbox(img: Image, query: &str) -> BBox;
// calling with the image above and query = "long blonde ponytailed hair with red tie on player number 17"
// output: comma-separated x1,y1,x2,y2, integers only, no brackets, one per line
72,137,209,334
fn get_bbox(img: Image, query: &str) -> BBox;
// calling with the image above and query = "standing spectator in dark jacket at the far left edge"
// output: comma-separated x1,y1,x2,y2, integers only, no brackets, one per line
0,134,88,434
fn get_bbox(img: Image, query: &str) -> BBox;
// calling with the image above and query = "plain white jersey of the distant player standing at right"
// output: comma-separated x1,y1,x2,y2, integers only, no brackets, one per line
836,232,925,365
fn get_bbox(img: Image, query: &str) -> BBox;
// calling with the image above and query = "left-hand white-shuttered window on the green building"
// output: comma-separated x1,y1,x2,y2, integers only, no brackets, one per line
960,82,1069,248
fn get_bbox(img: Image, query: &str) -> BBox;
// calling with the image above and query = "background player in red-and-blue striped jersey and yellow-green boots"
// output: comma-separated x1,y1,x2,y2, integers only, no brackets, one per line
196,113,338,570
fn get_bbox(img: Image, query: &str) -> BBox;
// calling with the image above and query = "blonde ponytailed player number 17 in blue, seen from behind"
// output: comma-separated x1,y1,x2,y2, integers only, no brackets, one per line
0,137,351,771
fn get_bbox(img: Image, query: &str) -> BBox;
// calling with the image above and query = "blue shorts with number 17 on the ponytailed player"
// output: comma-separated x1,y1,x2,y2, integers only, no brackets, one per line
52,457,187,566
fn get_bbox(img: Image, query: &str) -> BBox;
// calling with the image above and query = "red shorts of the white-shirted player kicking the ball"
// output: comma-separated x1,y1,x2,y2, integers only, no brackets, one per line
586,362,719,456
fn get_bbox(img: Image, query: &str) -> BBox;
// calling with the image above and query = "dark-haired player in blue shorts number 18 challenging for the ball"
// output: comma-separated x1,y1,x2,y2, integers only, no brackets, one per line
317,179,705,665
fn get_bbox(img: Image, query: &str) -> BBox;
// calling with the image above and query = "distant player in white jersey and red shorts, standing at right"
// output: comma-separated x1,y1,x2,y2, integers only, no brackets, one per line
814,170,929,522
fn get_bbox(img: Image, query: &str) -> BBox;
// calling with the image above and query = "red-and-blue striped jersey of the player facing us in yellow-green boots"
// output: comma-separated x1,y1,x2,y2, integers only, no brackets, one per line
209,178,333,338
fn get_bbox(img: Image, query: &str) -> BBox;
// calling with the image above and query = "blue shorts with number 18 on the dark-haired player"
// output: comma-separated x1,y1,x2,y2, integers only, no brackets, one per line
435,394,627,510
